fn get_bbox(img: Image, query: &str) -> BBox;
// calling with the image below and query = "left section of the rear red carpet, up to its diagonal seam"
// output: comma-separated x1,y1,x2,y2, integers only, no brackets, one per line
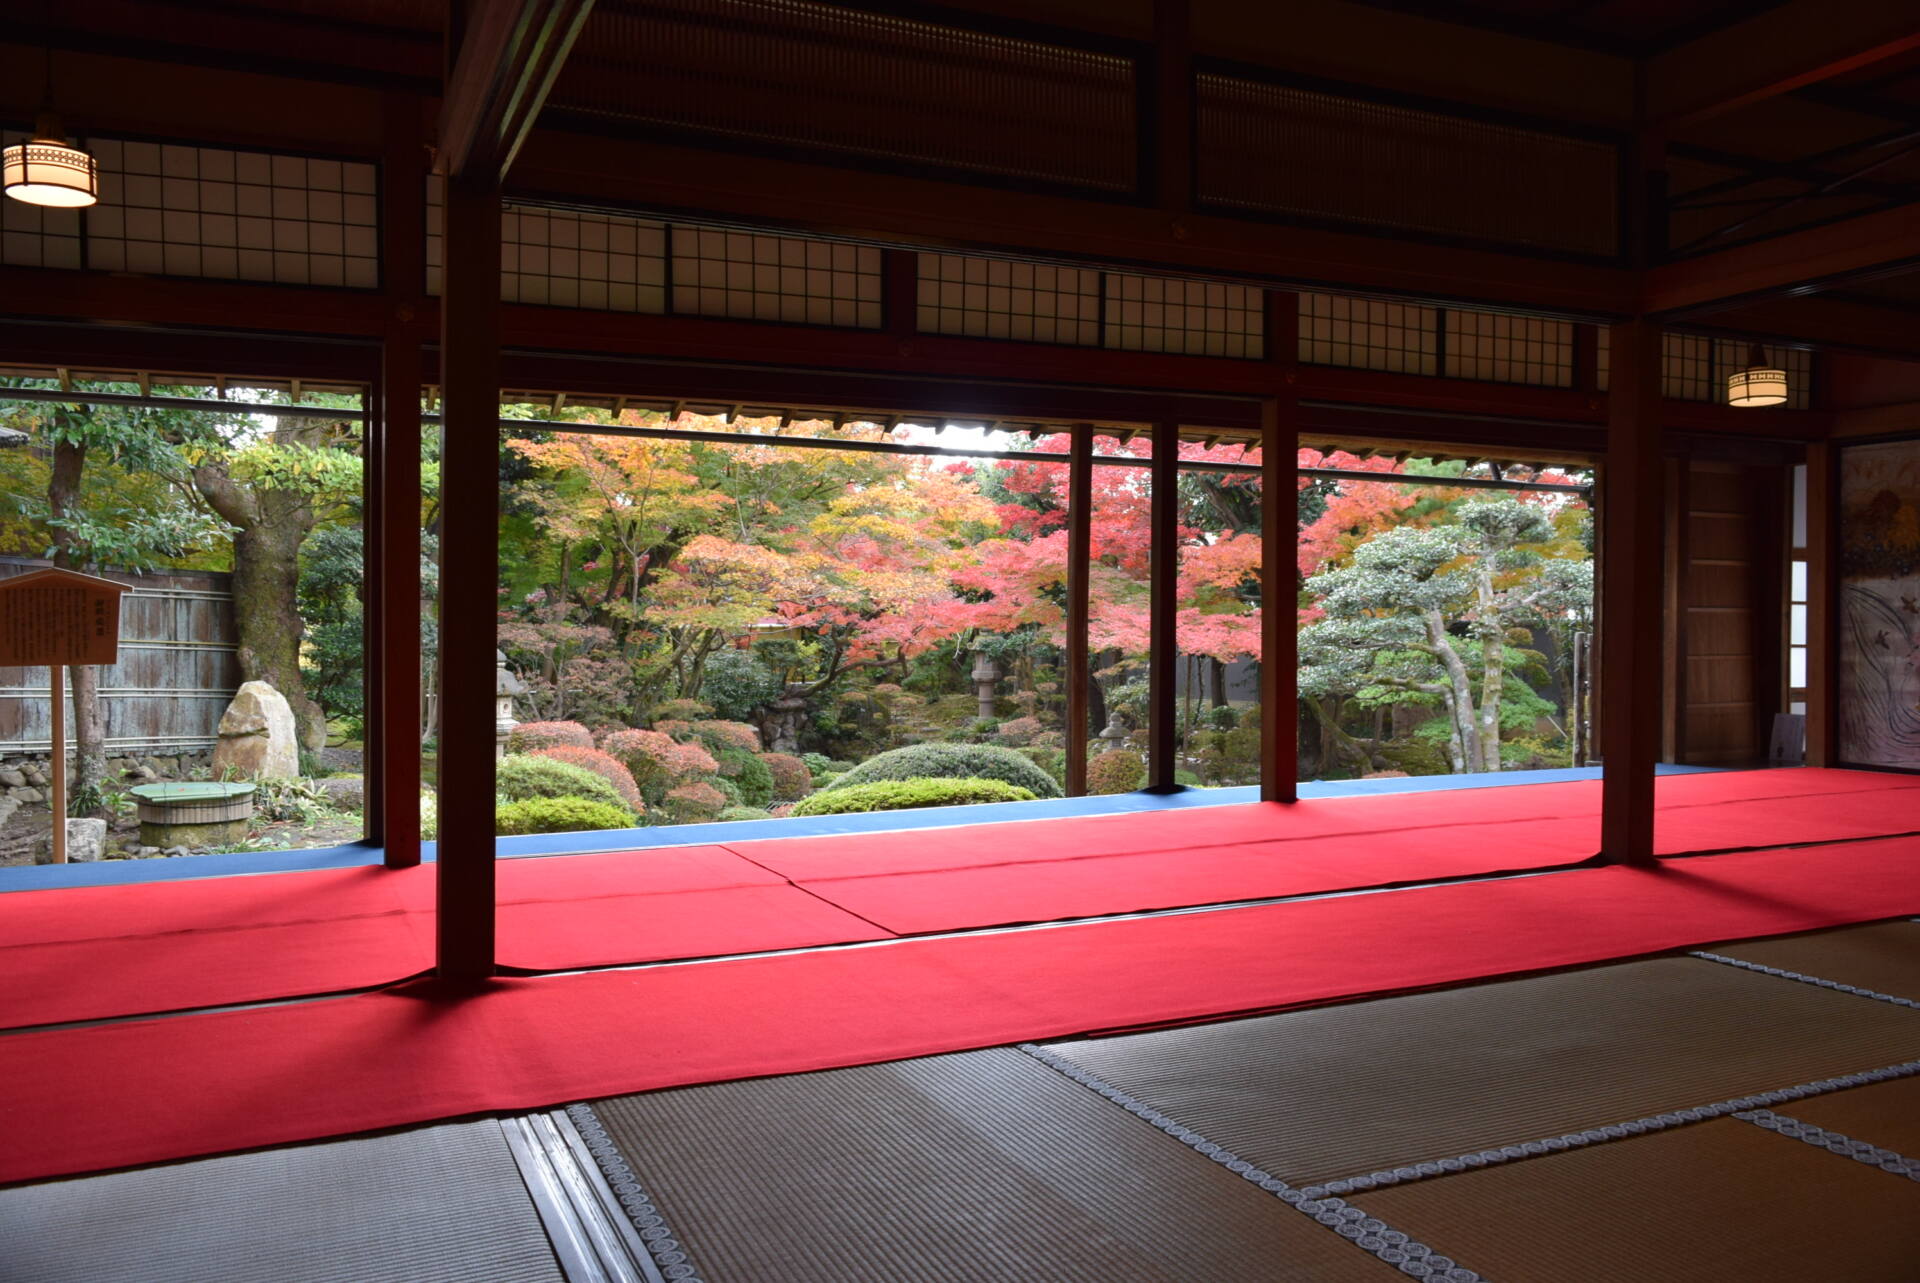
0,847,887,1029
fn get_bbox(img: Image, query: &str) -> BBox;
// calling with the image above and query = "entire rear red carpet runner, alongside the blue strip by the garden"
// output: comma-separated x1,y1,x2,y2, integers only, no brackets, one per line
0,770,1920,1029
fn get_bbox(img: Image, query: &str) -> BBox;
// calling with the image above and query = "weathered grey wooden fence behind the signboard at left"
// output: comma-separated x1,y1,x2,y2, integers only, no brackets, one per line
0,557,240,757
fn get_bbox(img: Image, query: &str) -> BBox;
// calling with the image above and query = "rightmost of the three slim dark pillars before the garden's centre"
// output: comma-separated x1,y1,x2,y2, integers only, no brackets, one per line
1260,388,1300,801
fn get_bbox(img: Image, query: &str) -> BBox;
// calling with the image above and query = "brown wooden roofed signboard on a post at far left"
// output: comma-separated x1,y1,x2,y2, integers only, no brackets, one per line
0,569,127,864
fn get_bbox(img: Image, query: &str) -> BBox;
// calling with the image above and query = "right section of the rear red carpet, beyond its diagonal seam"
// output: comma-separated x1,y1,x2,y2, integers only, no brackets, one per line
728,770,1920,935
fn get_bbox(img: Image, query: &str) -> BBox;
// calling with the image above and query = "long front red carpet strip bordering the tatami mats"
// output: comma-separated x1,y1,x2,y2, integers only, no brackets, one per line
0,837,1920,1181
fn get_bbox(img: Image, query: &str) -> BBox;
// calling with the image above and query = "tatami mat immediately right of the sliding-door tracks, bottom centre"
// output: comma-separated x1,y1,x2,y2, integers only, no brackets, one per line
593,1049,1400,1283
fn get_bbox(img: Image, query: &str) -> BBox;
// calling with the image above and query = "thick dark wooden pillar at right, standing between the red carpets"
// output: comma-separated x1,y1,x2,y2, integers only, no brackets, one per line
1599,319,1667,864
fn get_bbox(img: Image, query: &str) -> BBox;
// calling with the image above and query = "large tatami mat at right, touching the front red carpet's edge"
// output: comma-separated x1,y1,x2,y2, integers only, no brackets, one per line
1050,958,1920,1190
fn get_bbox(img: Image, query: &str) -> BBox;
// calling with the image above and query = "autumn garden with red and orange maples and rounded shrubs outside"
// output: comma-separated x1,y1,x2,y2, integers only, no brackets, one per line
0,388,1594,855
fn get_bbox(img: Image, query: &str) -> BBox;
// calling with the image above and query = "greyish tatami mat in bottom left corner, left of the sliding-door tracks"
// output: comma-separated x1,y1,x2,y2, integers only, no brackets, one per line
0,1122,561,1283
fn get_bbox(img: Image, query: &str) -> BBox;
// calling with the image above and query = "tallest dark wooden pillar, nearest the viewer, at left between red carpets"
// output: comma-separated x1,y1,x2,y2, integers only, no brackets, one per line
438,175,499,980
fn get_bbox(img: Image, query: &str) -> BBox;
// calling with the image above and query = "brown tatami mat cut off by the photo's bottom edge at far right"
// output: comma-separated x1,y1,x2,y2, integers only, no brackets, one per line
1354,1118,1920,1283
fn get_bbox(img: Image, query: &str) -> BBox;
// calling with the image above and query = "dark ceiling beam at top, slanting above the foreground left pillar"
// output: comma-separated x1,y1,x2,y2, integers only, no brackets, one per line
434,0,593,182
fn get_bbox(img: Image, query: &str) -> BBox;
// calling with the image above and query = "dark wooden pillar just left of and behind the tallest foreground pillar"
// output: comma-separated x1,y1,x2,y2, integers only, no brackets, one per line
363,94,426,868
